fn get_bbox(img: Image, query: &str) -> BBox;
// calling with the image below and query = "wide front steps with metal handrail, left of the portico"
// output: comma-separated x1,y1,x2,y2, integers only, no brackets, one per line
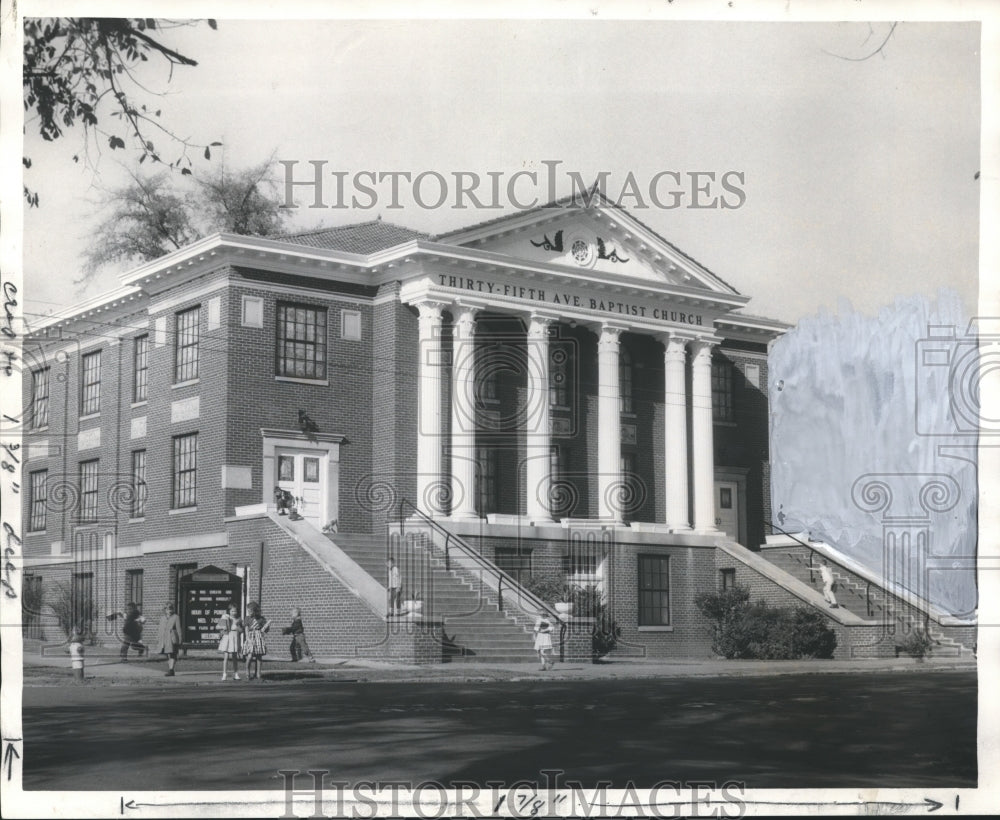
328,533,536,663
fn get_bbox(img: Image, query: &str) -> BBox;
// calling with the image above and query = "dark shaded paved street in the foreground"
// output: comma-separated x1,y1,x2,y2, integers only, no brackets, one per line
23,671,976,790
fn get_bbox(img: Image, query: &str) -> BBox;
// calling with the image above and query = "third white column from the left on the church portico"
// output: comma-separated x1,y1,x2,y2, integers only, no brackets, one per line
525,315,553,523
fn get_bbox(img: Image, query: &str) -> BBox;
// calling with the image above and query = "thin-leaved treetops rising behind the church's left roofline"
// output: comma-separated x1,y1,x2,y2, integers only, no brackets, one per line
78,158,289,281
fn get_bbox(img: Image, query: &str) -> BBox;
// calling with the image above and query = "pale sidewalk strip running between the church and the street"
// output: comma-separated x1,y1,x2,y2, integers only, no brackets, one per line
17,647,976,686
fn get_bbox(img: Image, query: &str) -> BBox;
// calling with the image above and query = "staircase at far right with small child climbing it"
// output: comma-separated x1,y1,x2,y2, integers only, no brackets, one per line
761,544,973,657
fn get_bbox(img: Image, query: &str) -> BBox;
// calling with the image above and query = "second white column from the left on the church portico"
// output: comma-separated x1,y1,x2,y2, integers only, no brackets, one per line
451,306,478,518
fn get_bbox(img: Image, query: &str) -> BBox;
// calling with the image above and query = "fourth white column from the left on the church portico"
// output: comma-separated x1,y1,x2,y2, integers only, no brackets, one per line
597,324,622,521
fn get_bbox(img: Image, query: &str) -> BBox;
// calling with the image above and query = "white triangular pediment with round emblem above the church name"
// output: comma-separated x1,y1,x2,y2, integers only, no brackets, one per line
437,201,737,294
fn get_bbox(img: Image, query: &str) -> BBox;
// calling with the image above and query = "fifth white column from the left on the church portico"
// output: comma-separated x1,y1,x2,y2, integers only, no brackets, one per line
660,333,691,532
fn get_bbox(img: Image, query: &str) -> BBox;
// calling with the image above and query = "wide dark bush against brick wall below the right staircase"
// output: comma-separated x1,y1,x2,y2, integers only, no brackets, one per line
695,587,837,660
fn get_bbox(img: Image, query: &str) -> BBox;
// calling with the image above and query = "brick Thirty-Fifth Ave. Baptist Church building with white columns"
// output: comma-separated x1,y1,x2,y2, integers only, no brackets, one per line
22,201,884,661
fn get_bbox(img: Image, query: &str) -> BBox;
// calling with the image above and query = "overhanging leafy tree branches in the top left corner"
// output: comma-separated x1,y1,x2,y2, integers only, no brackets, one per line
22,17,220,206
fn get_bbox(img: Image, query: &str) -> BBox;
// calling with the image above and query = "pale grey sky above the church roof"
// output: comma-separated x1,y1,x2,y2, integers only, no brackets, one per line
24,12,980,323
